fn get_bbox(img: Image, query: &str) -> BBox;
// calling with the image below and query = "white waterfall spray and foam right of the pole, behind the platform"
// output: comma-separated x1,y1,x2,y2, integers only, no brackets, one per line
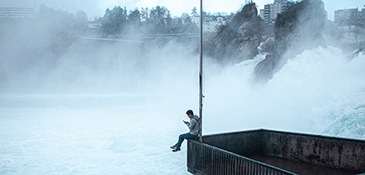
204,48,365,138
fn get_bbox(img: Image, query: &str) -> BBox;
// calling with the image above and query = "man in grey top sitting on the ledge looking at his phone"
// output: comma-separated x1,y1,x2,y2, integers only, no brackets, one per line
170,110,200,152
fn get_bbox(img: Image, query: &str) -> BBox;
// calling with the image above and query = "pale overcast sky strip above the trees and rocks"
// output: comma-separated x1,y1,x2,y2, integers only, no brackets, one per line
0,0,365,20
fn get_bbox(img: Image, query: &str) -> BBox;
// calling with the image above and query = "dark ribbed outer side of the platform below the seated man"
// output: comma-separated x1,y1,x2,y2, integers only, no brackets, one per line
187,140,295,175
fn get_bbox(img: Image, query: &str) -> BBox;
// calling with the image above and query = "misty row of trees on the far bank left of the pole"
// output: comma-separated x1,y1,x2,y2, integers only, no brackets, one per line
98,6,199,35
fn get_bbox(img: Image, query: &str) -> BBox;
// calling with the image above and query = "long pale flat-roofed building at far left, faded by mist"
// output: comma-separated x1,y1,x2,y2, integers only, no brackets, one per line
0,7,36,19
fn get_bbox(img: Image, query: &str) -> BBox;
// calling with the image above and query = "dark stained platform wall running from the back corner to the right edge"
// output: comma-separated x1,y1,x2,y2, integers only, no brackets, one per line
263,131,365,173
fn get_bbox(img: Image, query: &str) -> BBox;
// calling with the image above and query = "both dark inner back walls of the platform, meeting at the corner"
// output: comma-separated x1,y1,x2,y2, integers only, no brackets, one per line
203,129,365,173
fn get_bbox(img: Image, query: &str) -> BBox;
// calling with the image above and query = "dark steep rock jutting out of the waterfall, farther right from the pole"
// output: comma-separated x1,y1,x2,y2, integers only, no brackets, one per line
255,0,326,81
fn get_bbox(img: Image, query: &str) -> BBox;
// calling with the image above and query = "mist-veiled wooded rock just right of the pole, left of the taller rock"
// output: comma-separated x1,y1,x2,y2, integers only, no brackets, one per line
207,3,262,63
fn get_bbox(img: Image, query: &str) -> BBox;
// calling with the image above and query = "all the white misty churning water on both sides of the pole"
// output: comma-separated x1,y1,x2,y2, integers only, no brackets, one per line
0,40,365,174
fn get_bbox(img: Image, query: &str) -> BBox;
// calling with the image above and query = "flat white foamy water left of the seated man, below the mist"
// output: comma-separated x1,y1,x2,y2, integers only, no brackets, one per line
0,95,188,174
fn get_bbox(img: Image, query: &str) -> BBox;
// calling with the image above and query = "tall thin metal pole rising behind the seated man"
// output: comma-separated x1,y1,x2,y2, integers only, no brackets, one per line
199,0,203,142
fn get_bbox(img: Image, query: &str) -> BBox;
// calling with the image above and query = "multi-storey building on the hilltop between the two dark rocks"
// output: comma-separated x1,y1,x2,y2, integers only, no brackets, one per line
260,0,288,23
